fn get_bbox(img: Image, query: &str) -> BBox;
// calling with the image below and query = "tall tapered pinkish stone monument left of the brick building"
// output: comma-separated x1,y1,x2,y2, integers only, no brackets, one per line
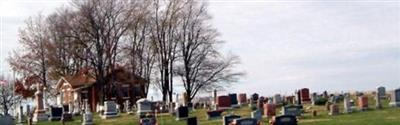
32,89,48,122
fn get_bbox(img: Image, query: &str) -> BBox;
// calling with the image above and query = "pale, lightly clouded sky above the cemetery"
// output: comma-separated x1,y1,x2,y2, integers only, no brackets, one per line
0,0,400,96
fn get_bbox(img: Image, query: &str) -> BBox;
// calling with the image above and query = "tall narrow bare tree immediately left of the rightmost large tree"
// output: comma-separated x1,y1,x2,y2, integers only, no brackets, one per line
152,0,184,102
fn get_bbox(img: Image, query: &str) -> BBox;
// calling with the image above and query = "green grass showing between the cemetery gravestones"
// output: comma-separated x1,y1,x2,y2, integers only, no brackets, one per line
38,97,400,125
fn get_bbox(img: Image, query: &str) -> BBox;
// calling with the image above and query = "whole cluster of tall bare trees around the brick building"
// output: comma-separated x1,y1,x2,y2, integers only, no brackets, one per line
8,0,242,102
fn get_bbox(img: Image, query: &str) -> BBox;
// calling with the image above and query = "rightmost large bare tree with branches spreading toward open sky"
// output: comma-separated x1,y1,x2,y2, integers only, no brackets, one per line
176,0,242,102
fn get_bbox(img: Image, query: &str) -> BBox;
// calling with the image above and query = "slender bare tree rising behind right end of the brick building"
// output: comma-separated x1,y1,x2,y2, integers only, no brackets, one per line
123,1,155,97
